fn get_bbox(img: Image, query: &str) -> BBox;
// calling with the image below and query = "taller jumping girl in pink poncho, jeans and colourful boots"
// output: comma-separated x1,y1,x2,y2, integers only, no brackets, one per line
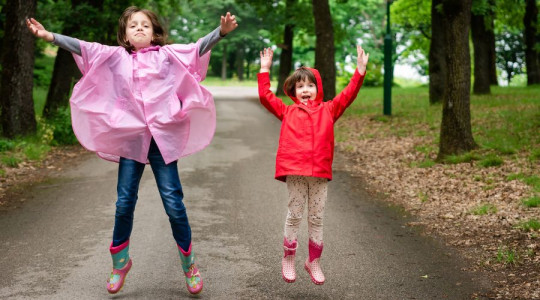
27,6,238,294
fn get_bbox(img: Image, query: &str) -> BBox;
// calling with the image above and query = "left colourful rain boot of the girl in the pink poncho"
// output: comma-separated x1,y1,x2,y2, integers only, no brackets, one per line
107,240,132,294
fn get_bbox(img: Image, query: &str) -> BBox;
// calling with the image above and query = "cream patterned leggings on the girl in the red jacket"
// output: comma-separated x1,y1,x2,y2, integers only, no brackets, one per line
285,175,328,244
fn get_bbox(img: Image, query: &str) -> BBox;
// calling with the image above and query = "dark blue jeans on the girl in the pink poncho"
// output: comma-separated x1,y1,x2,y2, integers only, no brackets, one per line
113,139,191,251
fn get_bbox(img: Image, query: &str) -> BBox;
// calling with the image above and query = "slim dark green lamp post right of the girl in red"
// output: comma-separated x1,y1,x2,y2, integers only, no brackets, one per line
383,0,394,116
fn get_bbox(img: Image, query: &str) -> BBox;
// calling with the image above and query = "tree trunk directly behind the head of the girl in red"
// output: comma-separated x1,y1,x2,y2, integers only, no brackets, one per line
312,0,336,99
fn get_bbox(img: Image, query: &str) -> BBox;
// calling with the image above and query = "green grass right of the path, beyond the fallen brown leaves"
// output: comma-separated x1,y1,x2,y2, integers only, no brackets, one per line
345,86,540,167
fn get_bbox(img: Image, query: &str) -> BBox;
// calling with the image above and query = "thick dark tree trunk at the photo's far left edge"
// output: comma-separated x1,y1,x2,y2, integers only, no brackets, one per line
0,0,36,138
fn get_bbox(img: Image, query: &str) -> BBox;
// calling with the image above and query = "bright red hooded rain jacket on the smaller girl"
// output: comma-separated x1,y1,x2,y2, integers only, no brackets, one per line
257,69,365,181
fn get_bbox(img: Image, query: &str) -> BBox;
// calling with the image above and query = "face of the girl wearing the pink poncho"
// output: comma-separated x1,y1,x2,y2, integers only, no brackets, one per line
126,12,154,51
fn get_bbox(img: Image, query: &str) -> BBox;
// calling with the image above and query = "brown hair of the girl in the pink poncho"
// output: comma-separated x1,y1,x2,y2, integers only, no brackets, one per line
116,6,167,52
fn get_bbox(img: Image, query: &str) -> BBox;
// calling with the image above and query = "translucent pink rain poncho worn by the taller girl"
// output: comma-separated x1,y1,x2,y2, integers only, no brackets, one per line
70,41,216,164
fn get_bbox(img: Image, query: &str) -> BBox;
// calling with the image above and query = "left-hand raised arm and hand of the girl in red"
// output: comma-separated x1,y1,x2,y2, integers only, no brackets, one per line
257,48,287,120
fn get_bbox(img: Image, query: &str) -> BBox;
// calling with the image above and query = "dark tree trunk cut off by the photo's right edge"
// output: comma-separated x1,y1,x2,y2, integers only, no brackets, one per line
523,0,540,85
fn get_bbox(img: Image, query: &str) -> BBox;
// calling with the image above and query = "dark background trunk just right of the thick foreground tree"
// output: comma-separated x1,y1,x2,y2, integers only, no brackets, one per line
471,14,493,94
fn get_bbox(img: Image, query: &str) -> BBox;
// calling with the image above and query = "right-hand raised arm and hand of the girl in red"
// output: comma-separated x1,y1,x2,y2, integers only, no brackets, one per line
331,45,369,120
